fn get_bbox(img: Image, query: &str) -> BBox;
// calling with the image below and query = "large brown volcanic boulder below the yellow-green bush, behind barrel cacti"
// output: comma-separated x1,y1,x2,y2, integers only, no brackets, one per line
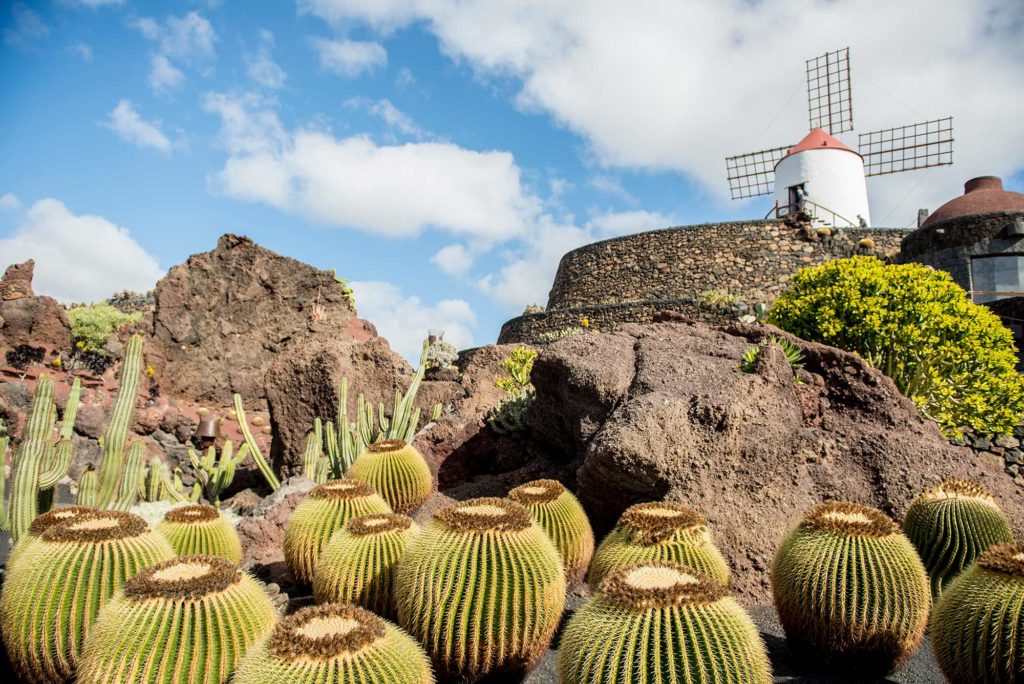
530,323,1024,603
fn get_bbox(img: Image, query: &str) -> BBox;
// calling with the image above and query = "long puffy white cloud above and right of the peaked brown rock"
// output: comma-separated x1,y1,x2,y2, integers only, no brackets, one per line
204,94,538,243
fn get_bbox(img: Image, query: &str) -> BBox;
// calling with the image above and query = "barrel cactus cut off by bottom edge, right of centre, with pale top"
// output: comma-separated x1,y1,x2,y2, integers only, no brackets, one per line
558,561,772,684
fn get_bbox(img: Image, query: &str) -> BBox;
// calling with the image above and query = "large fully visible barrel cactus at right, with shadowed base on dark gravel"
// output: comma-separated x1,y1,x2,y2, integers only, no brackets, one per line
771,502,931,675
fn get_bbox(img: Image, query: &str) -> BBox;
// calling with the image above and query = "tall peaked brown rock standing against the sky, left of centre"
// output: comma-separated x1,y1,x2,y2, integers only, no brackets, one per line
146,234,393,402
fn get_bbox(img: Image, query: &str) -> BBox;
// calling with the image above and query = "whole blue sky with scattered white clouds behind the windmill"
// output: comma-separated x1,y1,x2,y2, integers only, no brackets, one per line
0,0,1024,355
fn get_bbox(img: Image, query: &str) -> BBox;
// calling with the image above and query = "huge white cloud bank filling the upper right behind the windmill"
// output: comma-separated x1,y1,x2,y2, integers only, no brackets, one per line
304,0,1024,225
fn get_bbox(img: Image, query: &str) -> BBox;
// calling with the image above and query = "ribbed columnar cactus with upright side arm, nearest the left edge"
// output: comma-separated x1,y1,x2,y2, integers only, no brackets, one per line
0,376,82,542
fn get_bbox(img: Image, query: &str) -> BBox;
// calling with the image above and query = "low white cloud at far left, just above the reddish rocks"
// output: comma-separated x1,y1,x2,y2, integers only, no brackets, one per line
0,199,163,302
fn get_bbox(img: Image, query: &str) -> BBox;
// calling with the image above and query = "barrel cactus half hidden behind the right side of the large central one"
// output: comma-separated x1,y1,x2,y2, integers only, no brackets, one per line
509,480,594,584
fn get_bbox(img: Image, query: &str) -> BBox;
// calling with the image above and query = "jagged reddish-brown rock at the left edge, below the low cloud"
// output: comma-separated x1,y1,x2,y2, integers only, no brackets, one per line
0,259,71,358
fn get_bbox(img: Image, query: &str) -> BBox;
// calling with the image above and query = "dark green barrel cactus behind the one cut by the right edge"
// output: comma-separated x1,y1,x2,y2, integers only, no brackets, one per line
903,479,1014,596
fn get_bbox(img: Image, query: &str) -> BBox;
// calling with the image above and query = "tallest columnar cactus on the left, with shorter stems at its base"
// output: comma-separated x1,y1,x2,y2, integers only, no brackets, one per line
78,334,142,510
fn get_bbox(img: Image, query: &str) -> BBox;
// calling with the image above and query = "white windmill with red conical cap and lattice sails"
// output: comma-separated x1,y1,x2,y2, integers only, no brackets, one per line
725,47,953,226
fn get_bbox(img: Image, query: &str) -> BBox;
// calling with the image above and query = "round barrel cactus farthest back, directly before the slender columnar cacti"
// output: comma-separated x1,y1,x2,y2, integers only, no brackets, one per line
348,439,434,513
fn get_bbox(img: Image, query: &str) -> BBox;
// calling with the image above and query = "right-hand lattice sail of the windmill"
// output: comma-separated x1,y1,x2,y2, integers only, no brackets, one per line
857,117,953,176
